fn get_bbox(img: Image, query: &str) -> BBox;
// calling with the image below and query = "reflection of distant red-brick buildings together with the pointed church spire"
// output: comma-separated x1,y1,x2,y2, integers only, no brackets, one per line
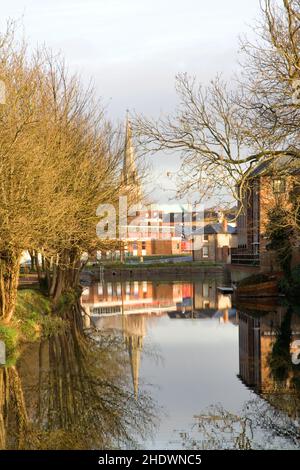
81,279,236,396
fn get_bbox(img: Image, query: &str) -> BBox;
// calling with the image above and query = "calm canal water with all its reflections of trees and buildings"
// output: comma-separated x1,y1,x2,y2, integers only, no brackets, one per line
0,276,300,449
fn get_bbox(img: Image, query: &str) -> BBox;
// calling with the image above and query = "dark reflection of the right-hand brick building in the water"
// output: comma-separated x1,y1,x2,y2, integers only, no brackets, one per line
238,306,300,416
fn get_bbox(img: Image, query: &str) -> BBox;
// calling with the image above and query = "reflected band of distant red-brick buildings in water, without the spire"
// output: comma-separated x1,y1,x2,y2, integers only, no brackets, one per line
82,279,236,323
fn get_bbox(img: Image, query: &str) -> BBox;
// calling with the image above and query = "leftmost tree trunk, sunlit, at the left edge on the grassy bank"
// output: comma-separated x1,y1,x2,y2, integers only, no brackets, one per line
0,250,21,323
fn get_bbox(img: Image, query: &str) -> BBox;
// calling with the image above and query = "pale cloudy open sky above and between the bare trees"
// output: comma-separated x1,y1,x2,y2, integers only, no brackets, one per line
0,0,259,202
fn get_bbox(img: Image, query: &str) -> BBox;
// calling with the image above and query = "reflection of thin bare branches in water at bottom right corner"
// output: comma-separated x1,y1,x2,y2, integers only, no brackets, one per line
179,398,300,450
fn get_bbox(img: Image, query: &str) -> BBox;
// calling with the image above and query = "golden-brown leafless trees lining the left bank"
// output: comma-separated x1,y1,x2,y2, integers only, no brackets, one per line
0,22,139,322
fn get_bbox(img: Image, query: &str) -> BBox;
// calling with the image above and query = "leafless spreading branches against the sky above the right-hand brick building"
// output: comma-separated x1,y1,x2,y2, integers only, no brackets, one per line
135,0,300,209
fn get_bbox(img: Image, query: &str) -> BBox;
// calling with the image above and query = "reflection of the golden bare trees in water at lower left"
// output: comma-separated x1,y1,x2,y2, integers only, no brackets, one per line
0,320,154,449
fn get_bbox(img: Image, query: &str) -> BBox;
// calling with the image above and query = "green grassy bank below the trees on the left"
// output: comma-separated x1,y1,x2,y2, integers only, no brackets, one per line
0,289,68,366
